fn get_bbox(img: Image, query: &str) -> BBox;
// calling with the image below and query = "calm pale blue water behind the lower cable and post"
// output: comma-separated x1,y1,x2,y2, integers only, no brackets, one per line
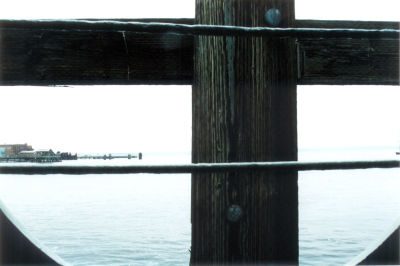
0,148,400,265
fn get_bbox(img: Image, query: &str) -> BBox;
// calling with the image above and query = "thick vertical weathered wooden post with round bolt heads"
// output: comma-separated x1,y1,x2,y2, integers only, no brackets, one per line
191,0,298,264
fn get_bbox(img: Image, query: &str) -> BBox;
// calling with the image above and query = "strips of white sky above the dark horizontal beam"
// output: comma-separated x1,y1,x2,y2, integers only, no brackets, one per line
0,0,400,21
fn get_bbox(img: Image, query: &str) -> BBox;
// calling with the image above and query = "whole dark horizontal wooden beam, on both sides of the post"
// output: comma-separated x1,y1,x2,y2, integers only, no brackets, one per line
0,19,399,85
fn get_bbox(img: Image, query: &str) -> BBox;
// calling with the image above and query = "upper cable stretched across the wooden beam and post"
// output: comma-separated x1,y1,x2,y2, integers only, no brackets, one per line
0,20,400,40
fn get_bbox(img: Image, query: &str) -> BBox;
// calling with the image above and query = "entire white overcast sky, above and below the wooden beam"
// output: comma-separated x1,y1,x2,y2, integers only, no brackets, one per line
0,0,400,152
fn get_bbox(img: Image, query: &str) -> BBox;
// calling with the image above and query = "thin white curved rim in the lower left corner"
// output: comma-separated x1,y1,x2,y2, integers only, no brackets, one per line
0,199,72,266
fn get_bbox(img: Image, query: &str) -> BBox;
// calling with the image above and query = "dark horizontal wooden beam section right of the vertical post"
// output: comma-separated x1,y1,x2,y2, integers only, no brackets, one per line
296,20,400,85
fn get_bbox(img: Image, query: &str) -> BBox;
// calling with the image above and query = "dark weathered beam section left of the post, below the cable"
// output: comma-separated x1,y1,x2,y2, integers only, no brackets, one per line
0,23,193,85
